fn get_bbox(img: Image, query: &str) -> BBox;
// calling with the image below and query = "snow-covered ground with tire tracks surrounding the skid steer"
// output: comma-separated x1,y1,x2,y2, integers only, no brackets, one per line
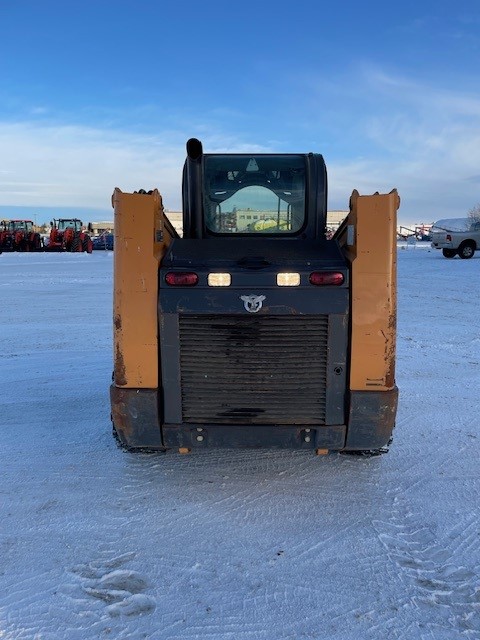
0,243,480,640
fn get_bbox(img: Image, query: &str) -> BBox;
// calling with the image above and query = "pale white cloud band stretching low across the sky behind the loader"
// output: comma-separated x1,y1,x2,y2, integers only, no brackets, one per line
0,64,480,228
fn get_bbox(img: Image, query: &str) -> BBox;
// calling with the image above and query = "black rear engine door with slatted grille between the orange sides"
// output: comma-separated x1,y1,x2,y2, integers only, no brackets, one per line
158,238,349,436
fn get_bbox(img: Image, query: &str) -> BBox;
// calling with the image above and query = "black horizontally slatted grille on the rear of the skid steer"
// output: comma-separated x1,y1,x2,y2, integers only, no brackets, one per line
179,315,328,425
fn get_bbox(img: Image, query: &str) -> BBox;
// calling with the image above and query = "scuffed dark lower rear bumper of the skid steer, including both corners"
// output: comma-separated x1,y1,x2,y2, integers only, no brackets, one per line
110,385,398,451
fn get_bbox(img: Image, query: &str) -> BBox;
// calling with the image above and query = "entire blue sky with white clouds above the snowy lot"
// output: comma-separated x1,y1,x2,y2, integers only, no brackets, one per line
0,0,480,223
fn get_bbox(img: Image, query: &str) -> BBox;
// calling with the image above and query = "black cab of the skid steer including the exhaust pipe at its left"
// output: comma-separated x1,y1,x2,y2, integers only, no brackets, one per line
183,138,327,240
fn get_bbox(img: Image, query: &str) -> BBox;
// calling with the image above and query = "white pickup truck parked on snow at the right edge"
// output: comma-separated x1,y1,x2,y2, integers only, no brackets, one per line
430,218,480,259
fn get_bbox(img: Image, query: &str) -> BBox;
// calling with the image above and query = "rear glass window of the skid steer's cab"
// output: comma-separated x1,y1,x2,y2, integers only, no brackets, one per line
204,155,305,235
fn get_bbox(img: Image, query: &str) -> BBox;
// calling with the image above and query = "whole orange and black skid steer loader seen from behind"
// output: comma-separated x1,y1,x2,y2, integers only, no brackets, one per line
110,139,400,454
